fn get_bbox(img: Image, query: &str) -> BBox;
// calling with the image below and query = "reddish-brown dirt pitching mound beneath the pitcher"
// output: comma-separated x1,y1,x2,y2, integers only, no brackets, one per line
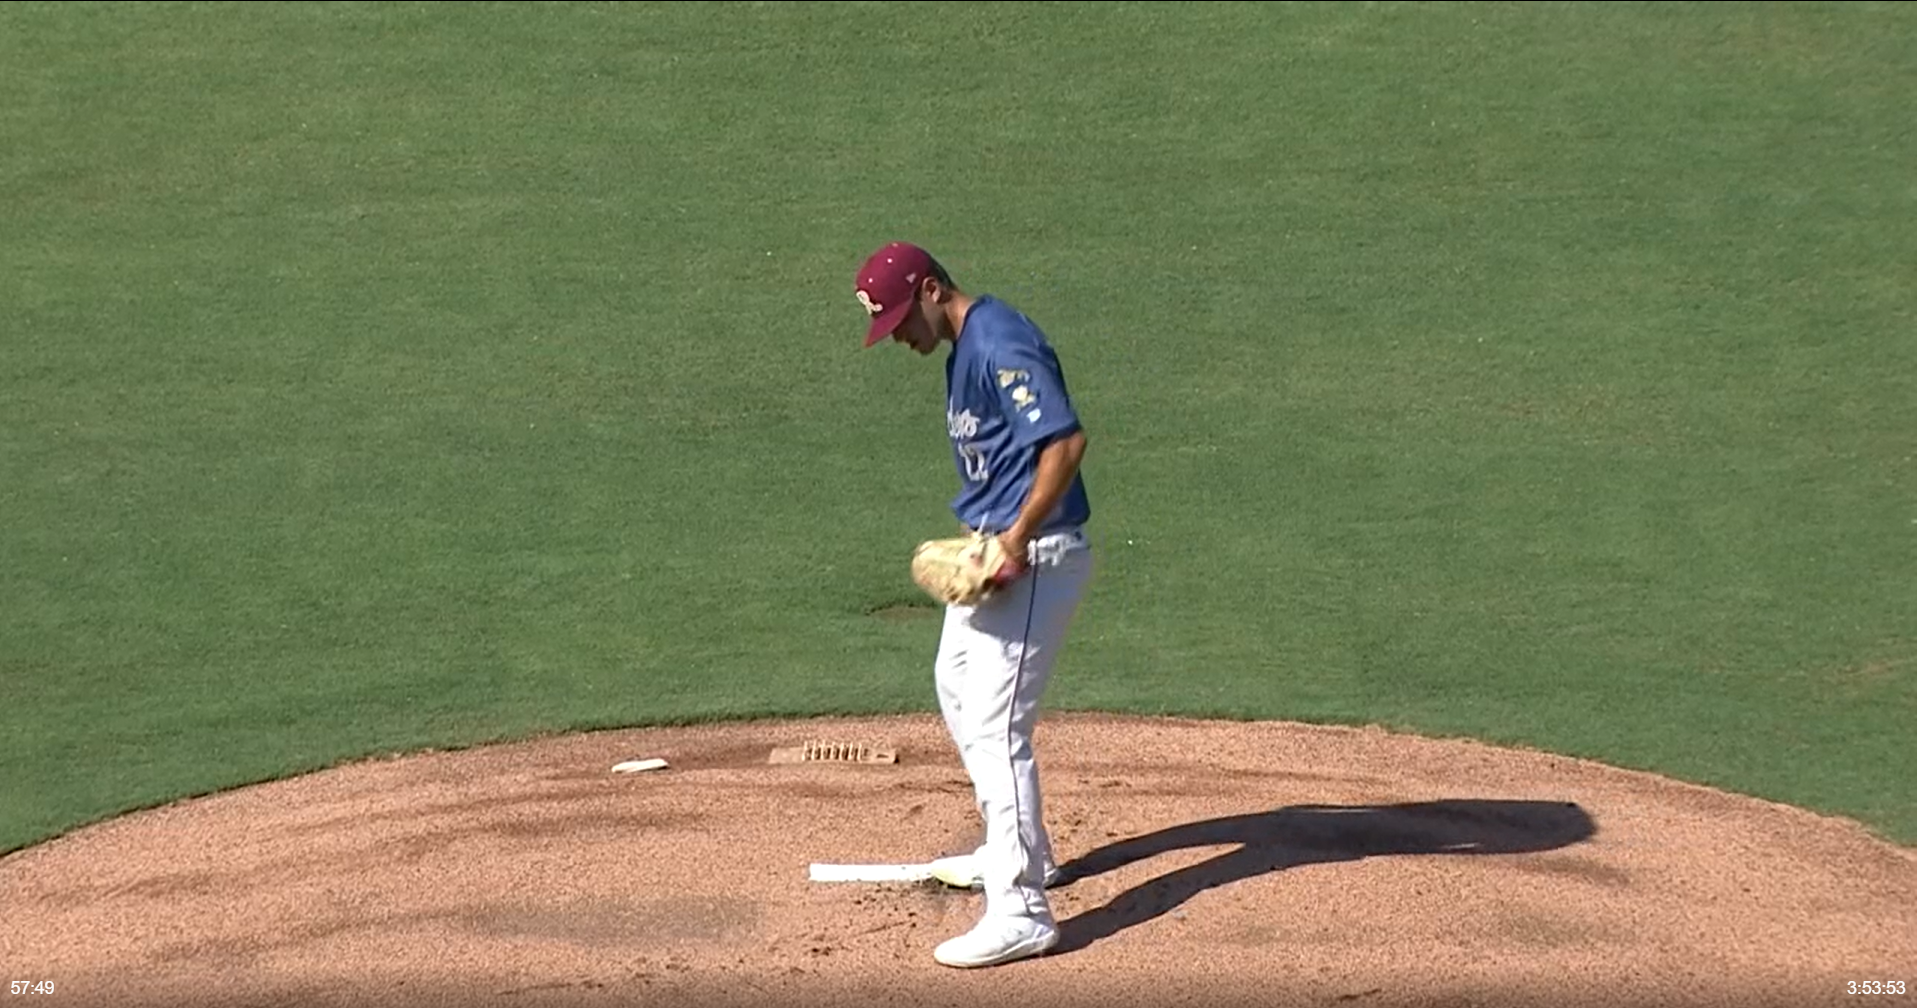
0,715,1917,1008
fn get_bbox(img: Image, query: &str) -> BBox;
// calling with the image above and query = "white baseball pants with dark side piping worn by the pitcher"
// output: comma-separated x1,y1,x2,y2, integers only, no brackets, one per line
934,531,1093,922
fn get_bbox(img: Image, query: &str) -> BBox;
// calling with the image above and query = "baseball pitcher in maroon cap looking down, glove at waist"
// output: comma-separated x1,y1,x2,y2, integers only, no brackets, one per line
855,241,1093,966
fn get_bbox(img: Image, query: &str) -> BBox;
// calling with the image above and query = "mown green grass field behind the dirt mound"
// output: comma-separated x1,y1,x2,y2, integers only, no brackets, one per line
0,4,1917,851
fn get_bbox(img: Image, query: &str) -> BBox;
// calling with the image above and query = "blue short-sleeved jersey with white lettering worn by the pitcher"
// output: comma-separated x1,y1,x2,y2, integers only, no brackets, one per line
945,295,1091,535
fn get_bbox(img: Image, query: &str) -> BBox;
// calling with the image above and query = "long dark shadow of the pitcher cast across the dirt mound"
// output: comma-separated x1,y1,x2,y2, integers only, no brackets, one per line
1052,799,1597,954
